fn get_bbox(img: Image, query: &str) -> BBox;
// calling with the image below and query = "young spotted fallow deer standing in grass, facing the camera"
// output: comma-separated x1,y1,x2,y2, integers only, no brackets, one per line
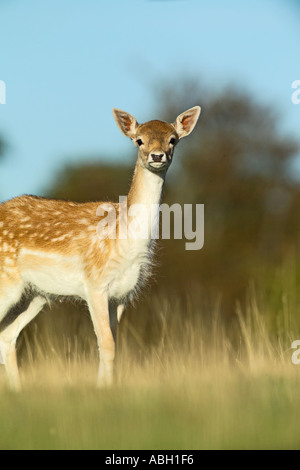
0,106,201,390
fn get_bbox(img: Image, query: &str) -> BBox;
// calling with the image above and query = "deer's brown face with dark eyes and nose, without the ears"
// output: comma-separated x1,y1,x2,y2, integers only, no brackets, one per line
132,121,179,172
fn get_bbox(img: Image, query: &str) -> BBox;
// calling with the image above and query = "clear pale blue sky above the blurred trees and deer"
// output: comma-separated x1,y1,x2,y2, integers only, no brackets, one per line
0,0,300,199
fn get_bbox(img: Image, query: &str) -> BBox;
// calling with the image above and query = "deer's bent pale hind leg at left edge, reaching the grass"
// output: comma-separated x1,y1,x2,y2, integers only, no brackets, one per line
0,296,46,390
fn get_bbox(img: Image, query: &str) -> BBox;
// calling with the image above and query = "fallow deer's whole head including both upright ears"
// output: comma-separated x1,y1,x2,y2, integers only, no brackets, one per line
113,106,200,172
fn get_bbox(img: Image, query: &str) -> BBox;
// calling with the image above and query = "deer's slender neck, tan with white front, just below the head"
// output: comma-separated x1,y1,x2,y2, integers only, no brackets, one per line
127,161,166,240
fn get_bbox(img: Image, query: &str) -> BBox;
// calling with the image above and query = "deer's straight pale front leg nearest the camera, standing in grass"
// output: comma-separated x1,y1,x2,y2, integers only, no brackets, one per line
88,290,115,388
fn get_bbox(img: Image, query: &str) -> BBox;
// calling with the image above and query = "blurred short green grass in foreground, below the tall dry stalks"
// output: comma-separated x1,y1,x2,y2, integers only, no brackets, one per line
0,371,300,450
